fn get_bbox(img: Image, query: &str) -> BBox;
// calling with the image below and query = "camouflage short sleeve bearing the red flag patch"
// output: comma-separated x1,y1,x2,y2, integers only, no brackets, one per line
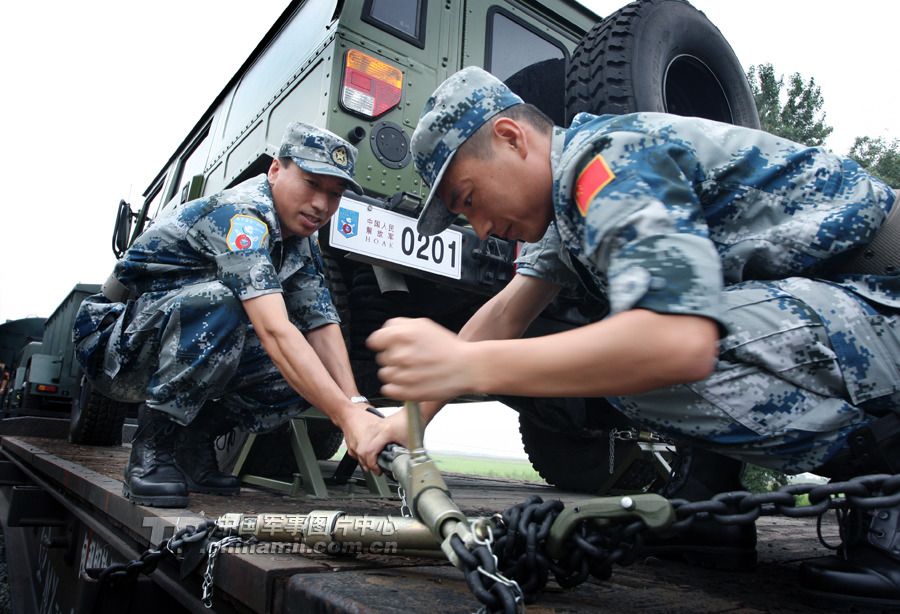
573,134,724,330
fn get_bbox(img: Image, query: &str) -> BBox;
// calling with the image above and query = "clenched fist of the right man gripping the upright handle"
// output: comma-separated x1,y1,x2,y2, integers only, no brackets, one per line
366,318,476,401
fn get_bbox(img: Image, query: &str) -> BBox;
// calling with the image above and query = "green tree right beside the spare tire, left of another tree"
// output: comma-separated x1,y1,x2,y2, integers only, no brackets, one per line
747,64,834,146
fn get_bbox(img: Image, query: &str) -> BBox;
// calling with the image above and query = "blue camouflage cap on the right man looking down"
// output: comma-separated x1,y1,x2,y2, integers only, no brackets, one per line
411,66,524,235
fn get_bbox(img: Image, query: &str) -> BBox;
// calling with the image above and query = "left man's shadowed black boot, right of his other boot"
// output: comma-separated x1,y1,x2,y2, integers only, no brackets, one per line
175,412,241,495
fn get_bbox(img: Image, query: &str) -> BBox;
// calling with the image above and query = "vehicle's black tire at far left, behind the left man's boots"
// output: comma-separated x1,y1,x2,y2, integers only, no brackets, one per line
69,376,129,446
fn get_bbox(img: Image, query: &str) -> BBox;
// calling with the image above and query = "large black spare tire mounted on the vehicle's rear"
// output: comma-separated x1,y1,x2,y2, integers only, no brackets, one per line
566,0,759,128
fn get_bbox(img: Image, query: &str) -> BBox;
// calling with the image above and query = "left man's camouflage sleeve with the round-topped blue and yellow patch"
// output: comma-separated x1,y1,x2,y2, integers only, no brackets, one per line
188,203,282,301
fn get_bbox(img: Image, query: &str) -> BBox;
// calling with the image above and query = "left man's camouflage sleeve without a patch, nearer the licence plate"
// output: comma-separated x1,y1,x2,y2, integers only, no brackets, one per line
281,237,341,330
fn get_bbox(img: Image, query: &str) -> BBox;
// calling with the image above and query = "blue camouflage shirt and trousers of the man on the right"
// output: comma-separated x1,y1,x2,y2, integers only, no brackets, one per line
517,113,900,472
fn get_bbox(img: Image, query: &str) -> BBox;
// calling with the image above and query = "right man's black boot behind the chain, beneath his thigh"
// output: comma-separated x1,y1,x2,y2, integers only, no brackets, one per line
641,447,756,571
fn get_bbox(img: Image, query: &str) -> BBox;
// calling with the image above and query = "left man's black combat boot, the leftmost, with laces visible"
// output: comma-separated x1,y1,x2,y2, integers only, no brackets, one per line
122,407,188,507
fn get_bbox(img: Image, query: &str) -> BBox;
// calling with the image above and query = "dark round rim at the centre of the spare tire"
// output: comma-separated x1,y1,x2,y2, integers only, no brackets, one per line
663,54,734,124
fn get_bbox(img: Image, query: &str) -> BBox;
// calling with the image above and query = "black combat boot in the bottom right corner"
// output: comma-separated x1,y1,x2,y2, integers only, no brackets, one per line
800,505,900,612
